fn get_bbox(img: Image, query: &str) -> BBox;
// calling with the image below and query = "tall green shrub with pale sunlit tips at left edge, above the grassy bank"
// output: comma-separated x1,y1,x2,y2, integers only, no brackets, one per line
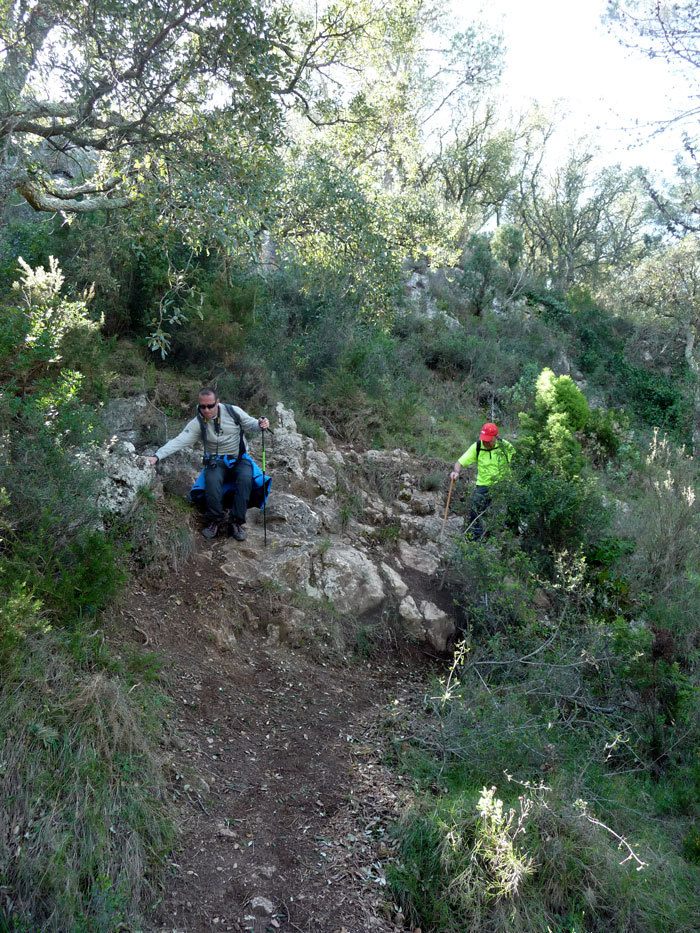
0,258,121,641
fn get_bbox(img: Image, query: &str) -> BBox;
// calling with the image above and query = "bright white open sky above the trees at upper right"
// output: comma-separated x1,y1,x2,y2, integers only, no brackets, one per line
464,0,685,175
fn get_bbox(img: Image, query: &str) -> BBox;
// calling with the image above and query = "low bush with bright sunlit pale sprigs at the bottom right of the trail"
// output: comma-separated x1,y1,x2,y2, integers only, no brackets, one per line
389,785,697,933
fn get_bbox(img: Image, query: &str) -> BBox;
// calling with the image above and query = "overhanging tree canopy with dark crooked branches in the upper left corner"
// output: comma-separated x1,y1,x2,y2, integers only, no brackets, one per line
0,0,298,212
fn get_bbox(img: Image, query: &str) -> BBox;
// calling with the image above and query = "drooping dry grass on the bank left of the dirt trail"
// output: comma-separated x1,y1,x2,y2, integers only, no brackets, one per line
0,638,171,933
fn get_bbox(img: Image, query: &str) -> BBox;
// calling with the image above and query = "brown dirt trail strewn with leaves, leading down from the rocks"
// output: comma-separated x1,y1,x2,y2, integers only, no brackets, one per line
119,541,421,933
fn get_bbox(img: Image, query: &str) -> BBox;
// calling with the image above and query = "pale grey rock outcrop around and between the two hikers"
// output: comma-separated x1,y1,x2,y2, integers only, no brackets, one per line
97,399,462,653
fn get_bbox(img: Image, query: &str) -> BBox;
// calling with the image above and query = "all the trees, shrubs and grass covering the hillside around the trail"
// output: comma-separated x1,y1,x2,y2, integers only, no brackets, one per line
0,0,700,933
